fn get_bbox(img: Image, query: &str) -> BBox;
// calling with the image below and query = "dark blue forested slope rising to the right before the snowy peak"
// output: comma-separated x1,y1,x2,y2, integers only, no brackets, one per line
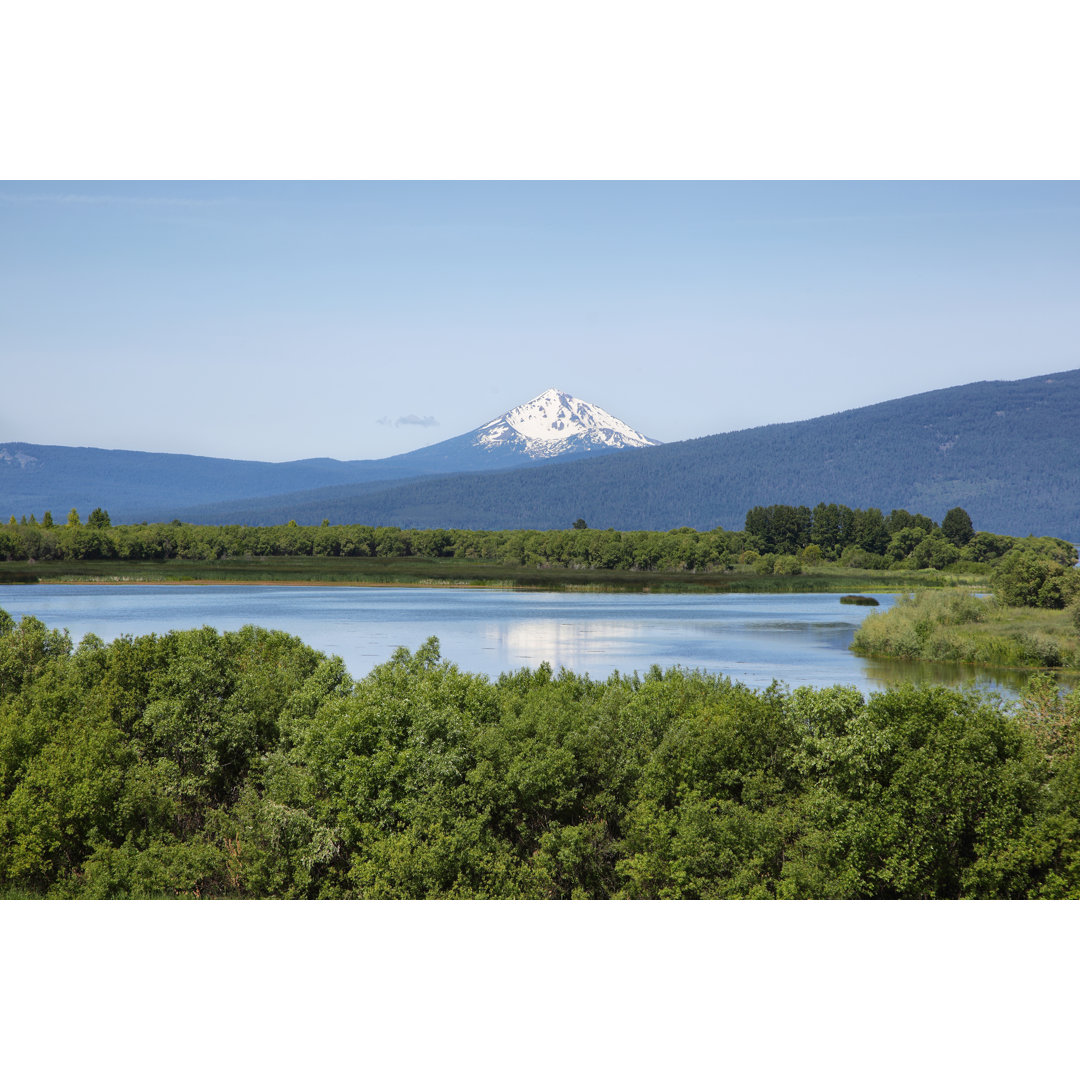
168,370,1080,538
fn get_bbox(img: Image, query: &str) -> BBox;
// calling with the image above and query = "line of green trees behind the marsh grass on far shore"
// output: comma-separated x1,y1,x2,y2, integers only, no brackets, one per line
0,503,1077,575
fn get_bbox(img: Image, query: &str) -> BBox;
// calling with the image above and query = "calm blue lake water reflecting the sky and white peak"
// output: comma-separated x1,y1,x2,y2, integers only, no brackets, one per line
0,585,1036,692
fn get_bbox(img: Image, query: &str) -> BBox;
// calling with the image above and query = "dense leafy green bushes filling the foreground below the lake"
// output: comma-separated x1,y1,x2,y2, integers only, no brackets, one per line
0,613,1080,899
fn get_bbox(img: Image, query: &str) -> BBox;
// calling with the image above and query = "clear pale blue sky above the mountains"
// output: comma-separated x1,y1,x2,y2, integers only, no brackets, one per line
0,181,1080,460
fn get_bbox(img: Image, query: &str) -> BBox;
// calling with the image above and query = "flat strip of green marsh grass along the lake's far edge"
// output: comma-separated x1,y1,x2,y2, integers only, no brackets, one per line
0,555,985,593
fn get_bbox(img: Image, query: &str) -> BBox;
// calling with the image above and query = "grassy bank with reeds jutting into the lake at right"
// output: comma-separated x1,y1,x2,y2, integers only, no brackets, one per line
851,589,1080,671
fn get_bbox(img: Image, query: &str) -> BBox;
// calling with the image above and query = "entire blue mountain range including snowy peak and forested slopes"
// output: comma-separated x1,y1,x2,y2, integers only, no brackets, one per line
0,370,1080,541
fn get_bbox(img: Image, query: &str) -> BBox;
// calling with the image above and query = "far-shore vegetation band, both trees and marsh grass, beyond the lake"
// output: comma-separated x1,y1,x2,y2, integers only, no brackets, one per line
0,503,1062,592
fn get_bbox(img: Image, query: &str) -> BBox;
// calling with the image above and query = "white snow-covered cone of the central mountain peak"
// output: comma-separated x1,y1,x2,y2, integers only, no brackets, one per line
473,388,660,458
